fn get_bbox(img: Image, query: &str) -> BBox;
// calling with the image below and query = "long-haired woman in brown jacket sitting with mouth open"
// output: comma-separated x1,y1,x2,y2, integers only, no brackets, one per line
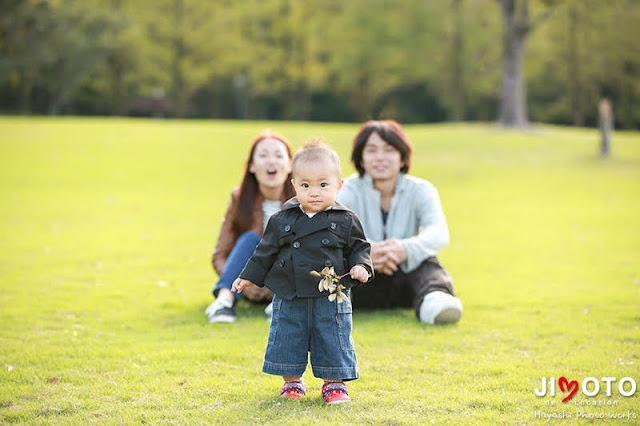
205,130,295,323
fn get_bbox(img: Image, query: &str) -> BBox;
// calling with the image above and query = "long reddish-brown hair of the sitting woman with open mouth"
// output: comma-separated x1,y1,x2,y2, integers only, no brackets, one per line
231,130,295,235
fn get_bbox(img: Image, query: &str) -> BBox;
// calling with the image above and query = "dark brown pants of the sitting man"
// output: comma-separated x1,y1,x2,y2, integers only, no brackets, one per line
351,256,455,317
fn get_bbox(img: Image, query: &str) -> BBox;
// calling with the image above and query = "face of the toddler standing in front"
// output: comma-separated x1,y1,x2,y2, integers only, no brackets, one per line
291,160,343,213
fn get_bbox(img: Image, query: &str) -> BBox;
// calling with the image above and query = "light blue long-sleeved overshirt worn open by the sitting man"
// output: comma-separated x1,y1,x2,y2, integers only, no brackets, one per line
337,173,449,273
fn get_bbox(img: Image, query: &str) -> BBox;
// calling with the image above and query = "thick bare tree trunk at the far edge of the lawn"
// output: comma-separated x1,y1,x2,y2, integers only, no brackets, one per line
498,0,529,128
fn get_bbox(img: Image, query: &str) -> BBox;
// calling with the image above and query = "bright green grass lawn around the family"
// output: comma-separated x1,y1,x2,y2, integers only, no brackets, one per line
0,118,640,425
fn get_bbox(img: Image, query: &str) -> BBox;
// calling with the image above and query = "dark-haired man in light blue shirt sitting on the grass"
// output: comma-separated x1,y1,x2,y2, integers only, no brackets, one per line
337,120,462,324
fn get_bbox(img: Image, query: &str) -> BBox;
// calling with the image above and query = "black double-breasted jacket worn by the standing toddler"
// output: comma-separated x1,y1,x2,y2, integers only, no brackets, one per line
240,197,373,300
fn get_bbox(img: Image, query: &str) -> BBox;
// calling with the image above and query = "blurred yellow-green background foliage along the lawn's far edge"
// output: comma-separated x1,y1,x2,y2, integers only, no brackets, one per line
0,0,640,128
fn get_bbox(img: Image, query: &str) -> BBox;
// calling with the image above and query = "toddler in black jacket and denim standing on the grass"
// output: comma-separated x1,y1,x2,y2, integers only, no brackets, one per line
232,142,373,404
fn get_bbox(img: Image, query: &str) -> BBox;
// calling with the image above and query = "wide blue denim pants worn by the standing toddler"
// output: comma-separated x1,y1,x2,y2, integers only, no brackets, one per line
262,290,359,380
